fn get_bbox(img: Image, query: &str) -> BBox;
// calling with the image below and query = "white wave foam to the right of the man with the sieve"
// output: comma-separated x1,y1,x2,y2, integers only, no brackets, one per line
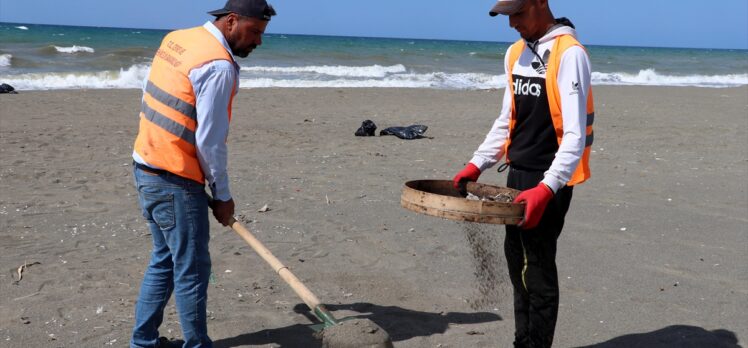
592,69,748,88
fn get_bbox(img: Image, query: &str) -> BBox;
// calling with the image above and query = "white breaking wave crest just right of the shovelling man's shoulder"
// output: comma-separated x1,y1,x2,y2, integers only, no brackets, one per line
242,64,407,78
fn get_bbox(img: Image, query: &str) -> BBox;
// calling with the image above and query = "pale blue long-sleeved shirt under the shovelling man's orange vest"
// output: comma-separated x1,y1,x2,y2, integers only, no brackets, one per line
132,22,239,201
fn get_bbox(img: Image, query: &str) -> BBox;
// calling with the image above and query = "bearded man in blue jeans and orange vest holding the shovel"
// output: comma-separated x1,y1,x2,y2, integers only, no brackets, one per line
130,0,275,347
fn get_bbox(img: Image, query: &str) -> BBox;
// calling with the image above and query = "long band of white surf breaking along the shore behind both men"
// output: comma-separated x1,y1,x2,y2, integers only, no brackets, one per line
0,64,748,90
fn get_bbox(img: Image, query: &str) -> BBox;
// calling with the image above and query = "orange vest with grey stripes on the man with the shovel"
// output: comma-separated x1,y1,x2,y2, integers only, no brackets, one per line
135,27,236,184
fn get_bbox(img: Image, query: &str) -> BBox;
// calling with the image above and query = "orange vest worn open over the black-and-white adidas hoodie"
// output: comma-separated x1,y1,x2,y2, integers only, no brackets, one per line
504,35,595,186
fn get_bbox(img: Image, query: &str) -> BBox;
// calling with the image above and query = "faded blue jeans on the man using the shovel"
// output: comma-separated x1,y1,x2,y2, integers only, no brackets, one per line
130,167,213,347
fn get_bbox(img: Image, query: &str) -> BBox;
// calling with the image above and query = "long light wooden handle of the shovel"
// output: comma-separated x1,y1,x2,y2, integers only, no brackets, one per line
229,218,320,310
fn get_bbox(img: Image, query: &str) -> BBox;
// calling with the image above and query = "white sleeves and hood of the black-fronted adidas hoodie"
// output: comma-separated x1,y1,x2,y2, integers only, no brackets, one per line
470,26,591,192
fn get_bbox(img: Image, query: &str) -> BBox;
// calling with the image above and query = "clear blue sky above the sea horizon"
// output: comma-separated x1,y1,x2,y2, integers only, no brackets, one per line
0,0,748,49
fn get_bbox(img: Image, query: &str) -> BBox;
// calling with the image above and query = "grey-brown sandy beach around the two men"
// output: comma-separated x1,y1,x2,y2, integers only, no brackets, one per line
0,86,748,348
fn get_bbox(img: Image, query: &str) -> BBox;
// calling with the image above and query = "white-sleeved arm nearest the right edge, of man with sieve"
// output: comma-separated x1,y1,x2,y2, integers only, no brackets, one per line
543,46,591,192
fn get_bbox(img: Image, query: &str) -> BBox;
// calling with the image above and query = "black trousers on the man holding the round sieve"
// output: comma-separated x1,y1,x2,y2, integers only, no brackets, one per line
504,168,572,348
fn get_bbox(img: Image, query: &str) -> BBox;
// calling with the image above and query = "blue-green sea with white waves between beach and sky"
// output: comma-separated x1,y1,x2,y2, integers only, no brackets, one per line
0,23,748,90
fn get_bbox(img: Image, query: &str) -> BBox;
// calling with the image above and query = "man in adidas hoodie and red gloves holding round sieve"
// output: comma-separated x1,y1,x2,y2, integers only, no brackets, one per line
454,0,594,347
